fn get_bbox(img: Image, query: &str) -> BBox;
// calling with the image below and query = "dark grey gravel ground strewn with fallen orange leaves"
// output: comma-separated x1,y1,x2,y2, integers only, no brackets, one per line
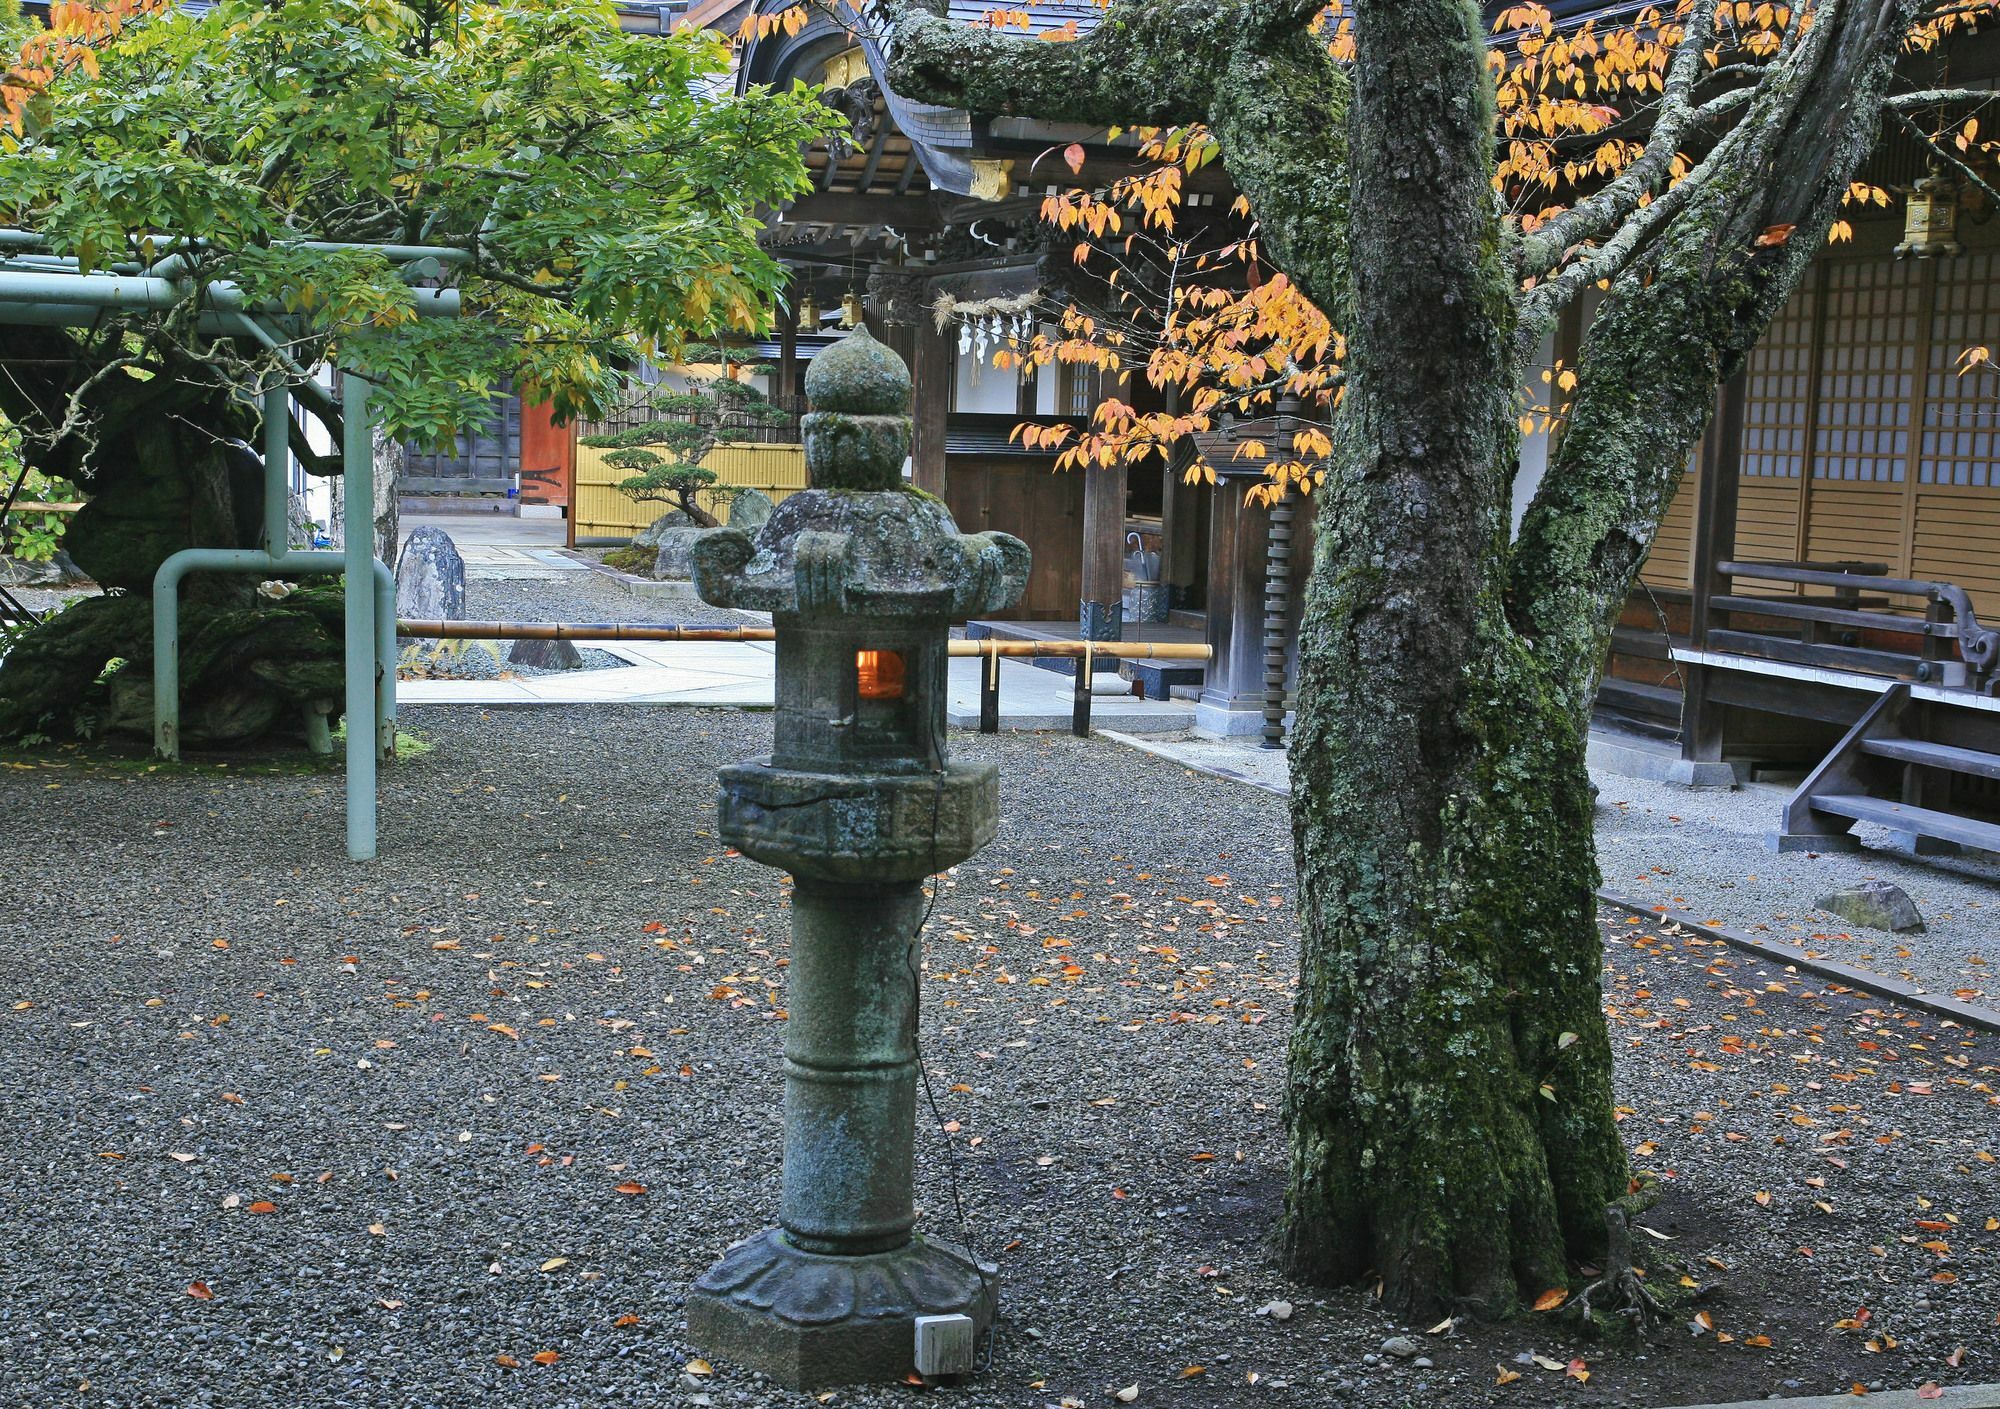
0,708,2000,1409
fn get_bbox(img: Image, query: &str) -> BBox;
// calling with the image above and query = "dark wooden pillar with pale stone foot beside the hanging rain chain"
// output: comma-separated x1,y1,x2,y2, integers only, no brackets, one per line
1194,474,1270,735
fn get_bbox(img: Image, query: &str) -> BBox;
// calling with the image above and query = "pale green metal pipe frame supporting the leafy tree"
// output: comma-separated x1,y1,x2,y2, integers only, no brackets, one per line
0,230,466,861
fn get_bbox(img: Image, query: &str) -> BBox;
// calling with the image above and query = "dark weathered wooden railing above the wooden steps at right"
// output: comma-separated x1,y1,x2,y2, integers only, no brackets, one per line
1702,562,2000,692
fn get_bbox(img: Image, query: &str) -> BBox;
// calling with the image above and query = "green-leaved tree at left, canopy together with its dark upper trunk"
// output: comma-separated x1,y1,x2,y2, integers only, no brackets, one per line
0,0,838,748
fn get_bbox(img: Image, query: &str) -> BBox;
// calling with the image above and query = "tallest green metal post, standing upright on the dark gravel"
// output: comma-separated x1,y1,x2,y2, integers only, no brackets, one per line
340,372,380,861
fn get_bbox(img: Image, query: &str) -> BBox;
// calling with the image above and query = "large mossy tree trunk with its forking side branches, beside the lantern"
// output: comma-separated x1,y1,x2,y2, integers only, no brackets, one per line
892,0,1916,1313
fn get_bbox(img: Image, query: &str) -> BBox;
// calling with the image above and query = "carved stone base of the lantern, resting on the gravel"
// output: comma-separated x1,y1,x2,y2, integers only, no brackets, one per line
688,1229,1000,1389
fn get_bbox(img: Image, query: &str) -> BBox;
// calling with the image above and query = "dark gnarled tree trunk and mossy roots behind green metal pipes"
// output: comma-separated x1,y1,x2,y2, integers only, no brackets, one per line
0,328,342,749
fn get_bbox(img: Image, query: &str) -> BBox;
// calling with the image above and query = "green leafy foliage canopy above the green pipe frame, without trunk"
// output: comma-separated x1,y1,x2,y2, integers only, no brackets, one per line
0,0,840,442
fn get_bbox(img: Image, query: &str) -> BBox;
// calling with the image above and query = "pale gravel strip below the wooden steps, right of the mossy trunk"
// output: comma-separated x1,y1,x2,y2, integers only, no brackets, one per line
1592,773,2000,1009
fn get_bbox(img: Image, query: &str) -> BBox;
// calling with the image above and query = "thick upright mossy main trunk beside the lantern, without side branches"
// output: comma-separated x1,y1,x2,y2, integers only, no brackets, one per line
1284,0,1626,1311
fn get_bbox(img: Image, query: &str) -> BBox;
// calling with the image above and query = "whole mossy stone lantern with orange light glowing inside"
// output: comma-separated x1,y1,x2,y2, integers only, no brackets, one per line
688,328,1028,1389
